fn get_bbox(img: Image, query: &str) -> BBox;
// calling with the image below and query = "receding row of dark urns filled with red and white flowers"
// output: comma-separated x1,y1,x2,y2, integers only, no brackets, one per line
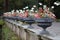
4,5,56,34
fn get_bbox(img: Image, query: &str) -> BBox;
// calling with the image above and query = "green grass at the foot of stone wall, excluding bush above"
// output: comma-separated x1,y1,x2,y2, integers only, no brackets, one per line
2,23,20,40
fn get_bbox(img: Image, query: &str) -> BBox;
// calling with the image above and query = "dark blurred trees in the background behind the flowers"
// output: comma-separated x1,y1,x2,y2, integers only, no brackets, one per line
0,0,60,18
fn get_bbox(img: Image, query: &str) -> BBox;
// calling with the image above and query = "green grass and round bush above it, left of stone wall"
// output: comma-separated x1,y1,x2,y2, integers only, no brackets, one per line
0,19,20,40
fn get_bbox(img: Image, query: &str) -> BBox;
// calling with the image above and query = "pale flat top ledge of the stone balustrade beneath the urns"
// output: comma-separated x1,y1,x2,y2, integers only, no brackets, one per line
5,18,59,40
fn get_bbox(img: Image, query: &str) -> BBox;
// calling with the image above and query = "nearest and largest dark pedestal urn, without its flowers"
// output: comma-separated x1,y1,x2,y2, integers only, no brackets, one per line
35,18,53,34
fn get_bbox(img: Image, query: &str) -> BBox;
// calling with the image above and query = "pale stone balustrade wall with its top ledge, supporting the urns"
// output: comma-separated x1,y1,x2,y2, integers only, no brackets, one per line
5,19,53,40
